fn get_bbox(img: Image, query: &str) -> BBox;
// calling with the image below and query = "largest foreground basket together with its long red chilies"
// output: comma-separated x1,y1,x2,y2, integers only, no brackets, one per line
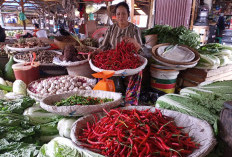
71,106,216,157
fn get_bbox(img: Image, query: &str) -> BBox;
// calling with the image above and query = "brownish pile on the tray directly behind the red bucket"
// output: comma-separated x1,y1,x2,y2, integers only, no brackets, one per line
15,50,58,63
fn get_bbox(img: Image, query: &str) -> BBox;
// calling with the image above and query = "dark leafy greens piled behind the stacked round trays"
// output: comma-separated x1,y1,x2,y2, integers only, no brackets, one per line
143,25,200,48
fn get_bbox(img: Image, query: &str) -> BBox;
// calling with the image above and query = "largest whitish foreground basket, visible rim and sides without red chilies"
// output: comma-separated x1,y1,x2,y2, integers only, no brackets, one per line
70,106,217,157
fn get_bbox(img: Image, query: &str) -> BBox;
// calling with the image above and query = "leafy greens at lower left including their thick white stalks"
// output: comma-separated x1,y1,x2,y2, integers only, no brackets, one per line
0,97,78,157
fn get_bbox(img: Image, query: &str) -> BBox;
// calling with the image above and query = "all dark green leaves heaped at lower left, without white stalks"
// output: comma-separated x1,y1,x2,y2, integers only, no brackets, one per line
0,97,39,156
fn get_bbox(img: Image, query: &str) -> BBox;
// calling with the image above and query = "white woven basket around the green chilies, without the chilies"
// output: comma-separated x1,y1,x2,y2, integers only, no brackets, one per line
40,90,122,116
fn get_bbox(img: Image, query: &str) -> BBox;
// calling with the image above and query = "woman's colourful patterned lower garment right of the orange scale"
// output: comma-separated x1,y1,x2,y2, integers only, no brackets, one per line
125,71,143,105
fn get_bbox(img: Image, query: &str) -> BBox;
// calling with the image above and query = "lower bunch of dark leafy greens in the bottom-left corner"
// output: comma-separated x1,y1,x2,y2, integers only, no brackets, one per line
0,112,40,157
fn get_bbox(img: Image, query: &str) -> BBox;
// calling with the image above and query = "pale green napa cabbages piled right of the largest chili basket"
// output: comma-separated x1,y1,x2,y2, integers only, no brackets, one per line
156,81,232,133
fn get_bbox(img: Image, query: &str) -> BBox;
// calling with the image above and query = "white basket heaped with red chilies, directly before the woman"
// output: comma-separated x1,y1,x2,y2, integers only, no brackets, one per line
89,41,147,76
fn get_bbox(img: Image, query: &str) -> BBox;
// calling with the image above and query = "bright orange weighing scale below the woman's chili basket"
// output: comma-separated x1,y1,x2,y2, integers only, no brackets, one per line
92,71,115,92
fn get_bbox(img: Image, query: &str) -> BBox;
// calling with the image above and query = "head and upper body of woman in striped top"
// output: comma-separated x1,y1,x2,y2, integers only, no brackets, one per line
99,2,142,50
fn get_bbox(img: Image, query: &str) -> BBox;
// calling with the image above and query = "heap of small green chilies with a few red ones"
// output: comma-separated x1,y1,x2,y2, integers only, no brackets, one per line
55,95,113,106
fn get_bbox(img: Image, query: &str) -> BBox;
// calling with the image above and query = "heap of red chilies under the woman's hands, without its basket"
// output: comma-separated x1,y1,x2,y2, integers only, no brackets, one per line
93,41,142,70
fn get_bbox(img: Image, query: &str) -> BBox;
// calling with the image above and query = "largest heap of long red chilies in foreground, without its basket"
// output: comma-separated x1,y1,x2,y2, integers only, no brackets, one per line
78,109,199,157
